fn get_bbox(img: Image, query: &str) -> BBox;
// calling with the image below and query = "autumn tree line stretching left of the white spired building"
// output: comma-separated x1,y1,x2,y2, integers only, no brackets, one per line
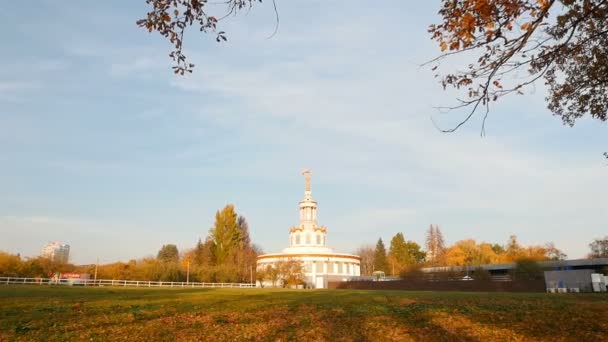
0,204,261,283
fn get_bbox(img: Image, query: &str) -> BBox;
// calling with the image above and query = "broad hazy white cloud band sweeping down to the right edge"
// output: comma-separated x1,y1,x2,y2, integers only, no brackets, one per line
163,18,608,257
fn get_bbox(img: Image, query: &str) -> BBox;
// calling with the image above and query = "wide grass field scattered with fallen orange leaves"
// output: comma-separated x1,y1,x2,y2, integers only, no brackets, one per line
0,286,608,341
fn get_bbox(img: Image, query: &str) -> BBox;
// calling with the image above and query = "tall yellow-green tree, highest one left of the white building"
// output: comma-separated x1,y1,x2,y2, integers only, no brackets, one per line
209,204,243,265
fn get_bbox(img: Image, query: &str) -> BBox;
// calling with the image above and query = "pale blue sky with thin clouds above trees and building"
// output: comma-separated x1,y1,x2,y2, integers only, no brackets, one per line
0,0,608,263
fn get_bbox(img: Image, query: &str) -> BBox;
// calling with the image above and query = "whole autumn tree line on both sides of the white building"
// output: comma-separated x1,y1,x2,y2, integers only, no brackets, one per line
0,219,608,280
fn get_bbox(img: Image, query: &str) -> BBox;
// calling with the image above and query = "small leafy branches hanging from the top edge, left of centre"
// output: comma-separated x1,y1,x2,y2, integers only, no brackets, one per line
137,0,262,75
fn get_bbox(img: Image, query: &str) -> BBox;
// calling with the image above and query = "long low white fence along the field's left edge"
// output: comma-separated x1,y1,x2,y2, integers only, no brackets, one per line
0,277,256,288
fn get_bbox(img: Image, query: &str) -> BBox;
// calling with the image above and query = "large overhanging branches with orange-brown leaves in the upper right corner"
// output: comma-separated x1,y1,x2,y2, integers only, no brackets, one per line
429,0,608,138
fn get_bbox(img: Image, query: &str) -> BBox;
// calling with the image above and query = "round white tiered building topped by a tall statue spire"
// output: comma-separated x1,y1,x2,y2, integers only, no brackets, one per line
257,170,361,288
